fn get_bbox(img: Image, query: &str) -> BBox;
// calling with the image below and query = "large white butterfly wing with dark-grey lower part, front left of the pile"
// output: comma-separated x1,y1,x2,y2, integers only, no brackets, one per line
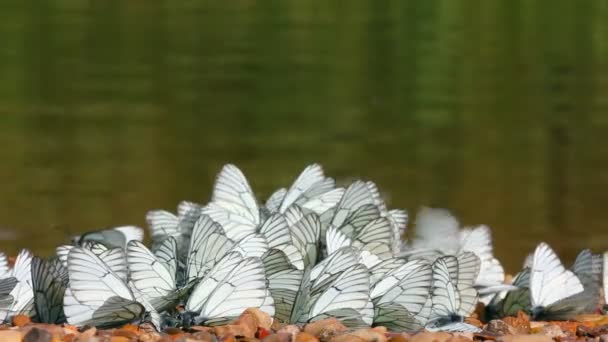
63,248,145,327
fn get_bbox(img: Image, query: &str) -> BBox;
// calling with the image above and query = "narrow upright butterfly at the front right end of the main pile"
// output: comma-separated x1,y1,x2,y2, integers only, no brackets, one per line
428,253,479,330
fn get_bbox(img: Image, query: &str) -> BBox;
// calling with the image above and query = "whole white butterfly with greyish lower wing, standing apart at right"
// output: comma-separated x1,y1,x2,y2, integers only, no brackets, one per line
530,243,587,319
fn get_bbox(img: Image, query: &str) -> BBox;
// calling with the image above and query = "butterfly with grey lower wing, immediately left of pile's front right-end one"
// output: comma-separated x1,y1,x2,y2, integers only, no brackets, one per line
371,260,432,331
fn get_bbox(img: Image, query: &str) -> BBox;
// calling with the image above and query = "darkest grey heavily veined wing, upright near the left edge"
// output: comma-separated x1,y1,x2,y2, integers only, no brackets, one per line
31,257,68,324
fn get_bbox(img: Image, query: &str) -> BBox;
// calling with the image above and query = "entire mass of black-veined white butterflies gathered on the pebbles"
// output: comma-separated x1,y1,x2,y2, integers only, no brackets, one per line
0,164,608,331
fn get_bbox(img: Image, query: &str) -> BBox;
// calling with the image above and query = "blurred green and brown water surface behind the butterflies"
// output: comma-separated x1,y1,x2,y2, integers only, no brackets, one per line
0,0,608,271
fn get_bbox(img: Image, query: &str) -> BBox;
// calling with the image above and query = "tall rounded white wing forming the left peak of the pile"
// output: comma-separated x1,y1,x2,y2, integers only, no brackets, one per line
202,164,261,239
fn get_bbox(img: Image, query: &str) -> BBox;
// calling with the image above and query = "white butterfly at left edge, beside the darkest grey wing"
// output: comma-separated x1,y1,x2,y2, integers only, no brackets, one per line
0,249,34,321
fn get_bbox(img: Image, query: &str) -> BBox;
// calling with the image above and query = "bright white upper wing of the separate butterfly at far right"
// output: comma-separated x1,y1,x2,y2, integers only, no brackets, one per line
530,243,583,307
